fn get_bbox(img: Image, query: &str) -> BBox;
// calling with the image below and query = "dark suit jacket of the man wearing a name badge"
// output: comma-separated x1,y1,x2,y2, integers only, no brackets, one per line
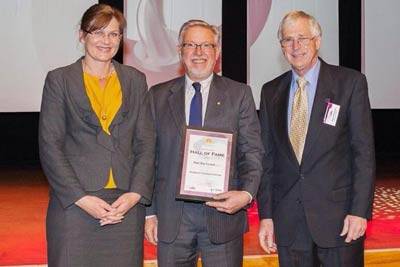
258,60,375,247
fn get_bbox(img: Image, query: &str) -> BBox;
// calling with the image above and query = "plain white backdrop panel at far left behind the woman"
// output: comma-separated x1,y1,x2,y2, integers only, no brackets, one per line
0,0,97,112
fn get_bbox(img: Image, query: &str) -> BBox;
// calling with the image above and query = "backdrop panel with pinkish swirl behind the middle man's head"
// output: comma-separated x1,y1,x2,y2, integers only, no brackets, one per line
124,0,222,86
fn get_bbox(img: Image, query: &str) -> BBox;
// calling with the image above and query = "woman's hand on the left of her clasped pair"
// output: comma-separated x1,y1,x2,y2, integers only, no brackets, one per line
75,195,115,219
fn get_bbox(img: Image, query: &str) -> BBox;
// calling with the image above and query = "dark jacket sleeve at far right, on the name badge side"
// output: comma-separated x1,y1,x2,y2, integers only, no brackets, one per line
348,75,375,218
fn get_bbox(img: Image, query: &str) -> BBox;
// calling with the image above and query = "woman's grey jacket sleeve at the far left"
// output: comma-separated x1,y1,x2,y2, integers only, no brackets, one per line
39,72,85,208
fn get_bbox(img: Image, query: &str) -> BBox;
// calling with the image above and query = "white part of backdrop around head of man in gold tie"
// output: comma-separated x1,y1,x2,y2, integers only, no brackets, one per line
247,0,339,108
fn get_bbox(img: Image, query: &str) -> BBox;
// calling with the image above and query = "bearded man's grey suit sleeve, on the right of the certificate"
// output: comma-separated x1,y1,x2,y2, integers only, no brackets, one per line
237,87,263,198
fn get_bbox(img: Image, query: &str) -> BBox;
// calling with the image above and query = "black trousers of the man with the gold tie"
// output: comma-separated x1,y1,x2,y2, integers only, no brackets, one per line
278,211,364,267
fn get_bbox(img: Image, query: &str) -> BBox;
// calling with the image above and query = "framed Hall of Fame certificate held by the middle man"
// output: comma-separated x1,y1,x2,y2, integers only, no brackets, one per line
176,127,236,201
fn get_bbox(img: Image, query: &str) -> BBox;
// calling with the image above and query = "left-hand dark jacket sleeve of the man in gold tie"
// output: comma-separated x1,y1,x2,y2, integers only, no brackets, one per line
257,89,274,220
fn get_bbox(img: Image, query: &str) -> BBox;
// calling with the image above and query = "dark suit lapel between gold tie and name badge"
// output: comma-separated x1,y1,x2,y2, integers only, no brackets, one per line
302,59,334,161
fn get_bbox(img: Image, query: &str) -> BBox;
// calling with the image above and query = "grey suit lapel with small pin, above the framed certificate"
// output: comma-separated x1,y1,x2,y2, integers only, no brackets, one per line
204,74,229,128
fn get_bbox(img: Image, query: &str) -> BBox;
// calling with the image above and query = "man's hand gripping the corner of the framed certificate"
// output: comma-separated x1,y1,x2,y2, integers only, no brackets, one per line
206,191,251,214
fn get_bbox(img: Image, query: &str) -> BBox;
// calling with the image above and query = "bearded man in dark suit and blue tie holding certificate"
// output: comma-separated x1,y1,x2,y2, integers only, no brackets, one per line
145,20,263,267
